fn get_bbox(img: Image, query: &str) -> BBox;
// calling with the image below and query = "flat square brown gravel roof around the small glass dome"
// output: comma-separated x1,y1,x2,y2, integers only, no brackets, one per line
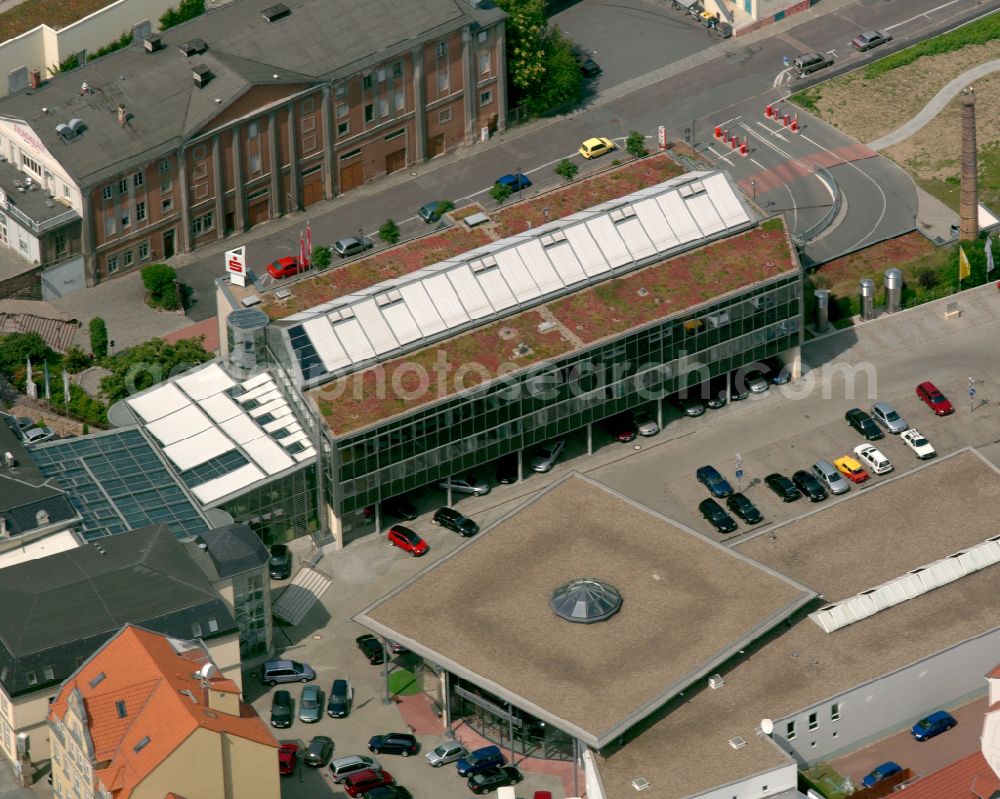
356,473,814,746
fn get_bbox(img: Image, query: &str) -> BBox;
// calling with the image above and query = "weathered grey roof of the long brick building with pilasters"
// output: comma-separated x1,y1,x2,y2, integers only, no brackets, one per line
0,0,504,186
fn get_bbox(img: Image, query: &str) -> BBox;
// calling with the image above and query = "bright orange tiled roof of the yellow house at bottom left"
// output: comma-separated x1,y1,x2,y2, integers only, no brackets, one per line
49,625,278,799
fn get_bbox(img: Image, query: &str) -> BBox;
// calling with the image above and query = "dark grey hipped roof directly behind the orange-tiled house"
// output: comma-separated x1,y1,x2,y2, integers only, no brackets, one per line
0,524,237,695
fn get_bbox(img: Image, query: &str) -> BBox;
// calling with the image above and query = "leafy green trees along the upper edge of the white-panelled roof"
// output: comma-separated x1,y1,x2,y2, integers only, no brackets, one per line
101,337,212,403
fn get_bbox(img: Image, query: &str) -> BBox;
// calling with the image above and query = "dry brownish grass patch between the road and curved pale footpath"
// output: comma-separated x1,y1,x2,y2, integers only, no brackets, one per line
811,42,1000,144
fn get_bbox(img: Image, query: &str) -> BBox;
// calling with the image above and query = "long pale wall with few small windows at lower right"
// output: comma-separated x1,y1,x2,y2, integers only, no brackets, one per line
774,622,1000,764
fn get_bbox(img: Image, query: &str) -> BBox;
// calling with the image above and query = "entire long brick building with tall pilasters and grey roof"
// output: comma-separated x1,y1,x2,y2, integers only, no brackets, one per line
0,0,507,288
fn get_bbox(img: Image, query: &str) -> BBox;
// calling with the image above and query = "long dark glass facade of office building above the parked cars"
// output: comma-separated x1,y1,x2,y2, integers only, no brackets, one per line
333,271,802,516
